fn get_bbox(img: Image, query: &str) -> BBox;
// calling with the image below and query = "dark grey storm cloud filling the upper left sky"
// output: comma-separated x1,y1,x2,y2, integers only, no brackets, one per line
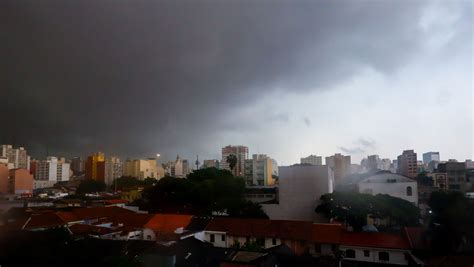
0,1,452,160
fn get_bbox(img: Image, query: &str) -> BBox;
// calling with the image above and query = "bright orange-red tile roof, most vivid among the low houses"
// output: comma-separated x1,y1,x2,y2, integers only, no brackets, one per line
145,214,193,233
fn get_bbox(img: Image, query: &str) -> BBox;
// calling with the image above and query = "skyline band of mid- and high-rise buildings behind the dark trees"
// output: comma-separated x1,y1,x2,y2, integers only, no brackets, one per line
0,142,474,226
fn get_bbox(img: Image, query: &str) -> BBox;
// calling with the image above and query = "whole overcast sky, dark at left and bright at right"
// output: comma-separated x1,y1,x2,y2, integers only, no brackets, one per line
0,0,474,165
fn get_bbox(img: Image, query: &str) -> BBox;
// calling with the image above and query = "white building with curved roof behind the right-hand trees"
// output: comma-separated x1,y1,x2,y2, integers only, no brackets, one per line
357,172,418,205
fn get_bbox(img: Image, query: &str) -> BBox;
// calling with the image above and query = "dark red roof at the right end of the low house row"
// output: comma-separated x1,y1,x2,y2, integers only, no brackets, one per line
341,231,410,249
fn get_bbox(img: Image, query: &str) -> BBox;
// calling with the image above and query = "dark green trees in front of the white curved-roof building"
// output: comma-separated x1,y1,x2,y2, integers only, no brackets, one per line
315,192,420,230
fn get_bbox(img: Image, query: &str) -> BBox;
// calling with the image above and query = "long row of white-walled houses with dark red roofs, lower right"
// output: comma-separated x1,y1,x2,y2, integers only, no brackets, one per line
204,218,416,265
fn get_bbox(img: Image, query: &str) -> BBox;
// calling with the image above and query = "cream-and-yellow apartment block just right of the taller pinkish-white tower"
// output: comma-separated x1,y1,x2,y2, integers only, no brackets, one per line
244,154,278,186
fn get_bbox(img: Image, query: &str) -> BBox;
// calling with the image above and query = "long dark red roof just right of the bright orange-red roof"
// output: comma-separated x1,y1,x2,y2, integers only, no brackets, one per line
206,218,313,240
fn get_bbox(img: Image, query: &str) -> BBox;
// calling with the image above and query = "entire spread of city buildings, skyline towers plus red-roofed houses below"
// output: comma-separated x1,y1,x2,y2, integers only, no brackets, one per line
0,145,474,266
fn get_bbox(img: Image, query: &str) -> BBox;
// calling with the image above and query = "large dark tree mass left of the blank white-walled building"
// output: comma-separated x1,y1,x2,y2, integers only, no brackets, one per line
142,174,268,218
